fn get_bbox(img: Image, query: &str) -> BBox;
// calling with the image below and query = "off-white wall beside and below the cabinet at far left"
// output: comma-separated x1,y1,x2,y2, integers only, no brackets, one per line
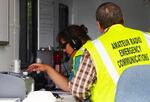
0,0,20,71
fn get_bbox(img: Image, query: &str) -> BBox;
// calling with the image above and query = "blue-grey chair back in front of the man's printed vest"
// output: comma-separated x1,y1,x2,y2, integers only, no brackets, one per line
115,65,150,102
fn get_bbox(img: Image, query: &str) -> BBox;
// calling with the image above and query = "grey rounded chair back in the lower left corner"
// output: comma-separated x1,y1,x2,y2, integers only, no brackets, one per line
0,73,26,100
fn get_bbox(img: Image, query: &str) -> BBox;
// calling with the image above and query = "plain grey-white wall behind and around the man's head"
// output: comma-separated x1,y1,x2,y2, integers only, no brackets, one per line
72,0,150,39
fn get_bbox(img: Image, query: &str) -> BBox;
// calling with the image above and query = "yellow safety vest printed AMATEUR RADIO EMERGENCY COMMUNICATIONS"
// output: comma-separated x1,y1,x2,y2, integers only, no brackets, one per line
86,24,150,102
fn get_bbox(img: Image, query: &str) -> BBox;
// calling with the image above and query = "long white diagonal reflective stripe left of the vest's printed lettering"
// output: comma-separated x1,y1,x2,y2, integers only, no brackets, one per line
93,39,119,84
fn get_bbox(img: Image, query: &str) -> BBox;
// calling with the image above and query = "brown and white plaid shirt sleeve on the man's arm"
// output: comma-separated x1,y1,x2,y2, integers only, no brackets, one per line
69,50,96,100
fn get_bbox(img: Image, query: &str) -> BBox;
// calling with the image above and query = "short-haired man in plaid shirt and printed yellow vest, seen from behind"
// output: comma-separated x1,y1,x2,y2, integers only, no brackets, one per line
69,2,150,102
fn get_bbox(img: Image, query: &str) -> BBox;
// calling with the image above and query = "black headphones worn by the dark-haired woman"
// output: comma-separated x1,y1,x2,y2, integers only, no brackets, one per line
66,30,82,50
